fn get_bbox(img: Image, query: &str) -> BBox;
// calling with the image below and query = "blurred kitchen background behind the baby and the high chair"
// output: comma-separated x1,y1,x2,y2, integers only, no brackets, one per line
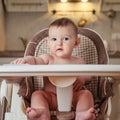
0,0,120,120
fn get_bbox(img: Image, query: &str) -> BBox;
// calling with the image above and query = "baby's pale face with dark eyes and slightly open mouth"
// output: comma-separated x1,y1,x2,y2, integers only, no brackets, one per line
48,25,78,58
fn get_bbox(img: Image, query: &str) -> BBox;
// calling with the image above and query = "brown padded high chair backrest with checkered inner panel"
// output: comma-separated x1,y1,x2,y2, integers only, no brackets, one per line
24,28,108,98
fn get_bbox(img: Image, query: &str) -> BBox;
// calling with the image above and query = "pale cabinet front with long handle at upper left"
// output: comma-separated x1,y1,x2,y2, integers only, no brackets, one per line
5,0,48,12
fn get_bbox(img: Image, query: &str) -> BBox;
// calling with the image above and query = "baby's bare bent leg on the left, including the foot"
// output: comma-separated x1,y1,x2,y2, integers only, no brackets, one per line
26,91,55,120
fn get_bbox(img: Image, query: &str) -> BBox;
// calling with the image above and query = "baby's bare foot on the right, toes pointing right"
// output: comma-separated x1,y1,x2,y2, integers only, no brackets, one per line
75,108,98,120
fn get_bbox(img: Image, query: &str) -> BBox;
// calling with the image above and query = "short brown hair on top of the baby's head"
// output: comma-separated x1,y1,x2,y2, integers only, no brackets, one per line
49,18,78,36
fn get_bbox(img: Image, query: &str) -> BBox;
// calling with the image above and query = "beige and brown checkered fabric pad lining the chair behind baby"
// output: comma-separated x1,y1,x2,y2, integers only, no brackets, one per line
34,34,98,97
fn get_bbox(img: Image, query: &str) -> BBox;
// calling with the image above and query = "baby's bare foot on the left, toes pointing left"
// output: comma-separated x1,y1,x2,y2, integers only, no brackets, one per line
26,107,50,120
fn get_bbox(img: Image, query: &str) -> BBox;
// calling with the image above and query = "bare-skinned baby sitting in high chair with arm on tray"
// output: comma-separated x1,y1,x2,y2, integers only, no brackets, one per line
12,18,97,120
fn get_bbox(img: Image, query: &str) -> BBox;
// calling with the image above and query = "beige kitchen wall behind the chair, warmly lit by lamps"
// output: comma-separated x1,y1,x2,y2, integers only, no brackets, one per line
2,1,120,50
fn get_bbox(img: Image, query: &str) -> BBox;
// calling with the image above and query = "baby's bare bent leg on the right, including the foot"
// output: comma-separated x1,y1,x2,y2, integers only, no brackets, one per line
75,90,97,120
